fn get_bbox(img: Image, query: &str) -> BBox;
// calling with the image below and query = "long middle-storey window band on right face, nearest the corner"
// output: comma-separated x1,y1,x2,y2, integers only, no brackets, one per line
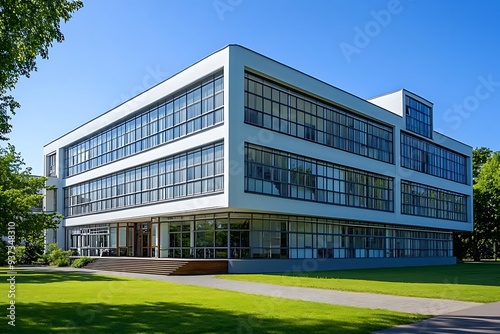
245,143,394,211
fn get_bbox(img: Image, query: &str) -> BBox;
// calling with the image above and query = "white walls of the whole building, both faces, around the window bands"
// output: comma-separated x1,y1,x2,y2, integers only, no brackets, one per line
44,45,473,270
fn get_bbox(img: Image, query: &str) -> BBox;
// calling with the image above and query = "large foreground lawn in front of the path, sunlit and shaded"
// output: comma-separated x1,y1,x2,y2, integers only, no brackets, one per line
0,270,425,334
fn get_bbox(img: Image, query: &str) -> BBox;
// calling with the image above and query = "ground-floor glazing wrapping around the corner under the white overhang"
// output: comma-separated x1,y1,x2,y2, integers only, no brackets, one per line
66,212,453,259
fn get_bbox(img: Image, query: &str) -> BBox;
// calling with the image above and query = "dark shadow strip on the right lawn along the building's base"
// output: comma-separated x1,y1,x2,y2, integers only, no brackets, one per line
268,262,500,286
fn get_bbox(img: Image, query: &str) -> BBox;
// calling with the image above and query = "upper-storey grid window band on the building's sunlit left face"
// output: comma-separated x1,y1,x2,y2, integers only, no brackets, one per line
66,73,224,176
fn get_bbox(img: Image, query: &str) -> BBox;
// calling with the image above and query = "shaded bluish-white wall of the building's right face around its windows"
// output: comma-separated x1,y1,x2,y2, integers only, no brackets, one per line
229,47,473,231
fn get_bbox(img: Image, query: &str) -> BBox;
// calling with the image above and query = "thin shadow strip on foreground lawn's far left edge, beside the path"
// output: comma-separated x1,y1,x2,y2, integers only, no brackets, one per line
0,269,122,284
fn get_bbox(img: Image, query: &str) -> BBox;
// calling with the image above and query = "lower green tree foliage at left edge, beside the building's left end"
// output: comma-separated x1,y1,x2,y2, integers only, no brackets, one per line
0,145,61,244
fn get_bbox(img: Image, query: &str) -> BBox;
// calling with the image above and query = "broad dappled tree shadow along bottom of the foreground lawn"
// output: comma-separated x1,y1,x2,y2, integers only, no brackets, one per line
12,302,418,334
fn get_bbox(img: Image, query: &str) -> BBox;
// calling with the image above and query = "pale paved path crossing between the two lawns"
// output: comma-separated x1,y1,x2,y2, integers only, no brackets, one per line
30,267,481,315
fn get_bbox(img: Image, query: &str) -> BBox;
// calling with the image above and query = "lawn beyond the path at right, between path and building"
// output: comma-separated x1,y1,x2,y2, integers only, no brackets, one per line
219,262,500,303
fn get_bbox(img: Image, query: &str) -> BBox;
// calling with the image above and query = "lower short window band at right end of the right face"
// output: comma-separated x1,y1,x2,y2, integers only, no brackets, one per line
401,180,467,222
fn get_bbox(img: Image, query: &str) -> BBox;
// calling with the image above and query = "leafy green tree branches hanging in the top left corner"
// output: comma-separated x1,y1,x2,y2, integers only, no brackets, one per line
0,0,83,140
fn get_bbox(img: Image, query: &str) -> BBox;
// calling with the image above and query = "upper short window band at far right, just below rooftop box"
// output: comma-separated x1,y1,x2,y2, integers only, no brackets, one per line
401,132,467,183
